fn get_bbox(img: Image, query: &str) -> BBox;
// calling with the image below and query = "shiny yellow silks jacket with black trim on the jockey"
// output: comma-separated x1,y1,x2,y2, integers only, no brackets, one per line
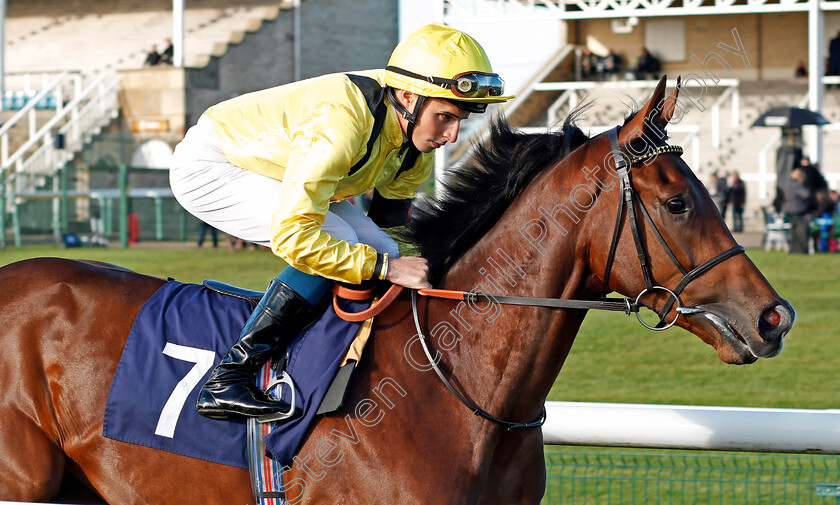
205,70,434,284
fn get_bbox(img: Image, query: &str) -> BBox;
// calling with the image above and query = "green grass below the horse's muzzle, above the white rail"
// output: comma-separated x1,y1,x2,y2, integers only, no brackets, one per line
549,250,840,408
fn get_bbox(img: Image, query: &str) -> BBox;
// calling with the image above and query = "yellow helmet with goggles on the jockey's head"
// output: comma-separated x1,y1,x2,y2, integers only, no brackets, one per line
385,23,513,110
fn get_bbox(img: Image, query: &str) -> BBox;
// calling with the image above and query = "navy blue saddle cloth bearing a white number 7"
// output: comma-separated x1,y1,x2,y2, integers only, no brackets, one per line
103,281,367,468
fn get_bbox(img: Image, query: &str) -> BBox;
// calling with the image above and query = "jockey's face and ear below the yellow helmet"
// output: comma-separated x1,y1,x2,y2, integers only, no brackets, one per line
397,91,470,153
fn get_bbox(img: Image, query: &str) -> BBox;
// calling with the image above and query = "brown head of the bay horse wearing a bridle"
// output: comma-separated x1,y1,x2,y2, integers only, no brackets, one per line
570,77,796,364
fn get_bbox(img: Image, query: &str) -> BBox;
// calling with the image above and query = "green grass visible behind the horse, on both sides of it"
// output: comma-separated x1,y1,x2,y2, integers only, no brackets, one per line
0,244,840,408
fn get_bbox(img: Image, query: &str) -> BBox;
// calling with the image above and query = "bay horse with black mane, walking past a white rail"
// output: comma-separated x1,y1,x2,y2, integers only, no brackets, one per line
0,78,795,505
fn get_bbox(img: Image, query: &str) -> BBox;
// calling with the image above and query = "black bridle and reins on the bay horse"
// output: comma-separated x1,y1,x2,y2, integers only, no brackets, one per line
411,126,744,431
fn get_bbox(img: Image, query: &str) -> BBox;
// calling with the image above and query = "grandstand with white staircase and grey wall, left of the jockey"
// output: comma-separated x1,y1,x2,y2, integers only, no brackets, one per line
0,0,398,243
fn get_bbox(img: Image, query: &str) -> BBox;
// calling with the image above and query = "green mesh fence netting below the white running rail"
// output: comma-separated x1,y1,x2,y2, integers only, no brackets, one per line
542,448,840,505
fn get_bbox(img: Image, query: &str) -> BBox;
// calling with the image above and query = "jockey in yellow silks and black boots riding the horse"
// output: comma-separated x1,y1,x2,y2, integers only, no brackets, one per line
170,24,513,419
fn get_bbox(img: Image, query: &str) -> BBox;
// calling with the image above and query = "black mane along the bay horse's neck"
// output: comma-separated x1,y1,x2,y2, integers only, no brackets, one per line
408,109,589,283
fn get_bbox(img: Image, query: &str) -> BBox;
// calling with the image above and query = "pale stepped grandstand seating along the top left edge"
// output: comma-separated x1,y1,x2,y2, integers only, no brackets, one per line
6,0,291,74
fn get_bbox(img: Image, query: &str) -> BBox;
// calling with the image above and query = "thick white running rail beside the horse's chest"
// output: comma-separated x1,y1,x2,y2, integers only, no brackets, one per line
542,402,840,454
